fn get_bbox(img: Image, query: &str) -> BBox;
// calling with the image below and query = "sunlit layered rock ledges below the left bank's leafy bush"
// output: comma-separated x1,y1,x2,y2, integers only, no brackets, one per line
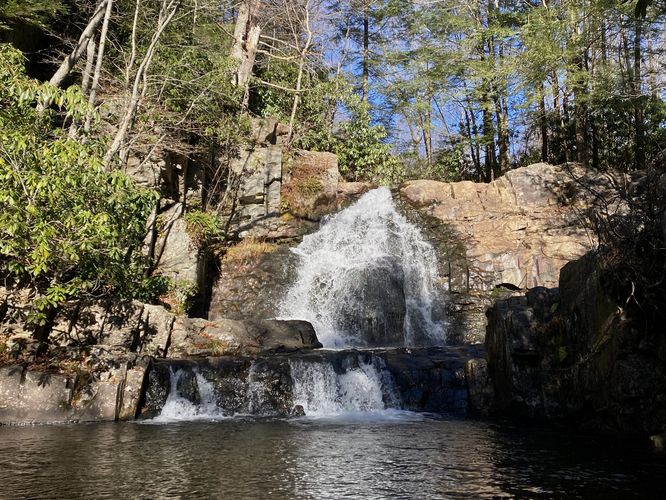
0,301,321,423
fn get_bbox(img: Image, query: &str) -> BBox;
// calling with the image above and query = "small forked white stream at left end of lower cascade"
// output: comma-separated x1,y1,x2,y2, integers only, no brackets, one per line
152,369,224,423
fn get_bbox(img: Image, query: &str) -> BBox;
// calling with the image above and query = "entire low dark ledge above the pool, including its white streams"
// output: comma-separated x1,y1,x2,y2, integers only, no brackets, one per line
143,347,478,422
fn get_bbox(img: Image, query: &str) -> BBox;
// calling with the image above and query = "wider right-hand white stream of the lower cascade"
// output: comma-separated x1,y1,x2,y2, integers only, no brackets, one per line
289,357,400,417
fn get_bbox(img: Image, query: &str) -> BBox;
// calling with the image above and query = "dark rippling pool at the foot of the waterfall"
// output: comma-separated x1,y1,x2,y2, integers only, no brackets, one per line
0,417,666,499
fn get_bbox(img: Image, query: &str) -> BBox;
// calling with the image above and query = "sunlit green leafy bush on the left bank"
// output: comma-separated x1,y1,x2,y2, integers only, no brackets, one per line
0,46,155,324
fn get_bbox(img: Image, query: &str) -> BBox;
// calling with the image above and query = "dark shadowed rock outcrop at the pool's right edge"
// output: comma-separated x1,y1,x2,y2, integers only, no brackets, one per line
486,254,666,435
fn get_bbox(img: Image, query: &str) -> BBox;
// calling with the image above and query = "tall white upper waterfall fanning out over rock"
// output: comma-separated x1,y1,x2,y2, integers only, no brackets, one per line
279,188,444,347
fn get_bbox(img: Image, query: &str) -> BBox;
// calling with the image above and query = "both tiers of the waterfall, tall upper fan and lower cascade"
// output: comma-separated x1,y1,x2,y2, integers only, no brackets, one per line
143,188,445,421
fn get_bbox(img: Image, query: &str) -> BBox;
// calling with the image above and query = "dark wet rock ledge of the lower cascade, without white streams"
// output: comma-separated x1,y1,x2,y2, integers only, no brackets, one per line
141,346,483,417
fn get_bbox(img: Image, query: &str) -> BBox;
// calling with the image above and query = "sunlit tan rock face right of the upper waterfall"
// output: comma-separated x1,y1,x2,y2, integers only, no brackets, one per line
400,163,609,341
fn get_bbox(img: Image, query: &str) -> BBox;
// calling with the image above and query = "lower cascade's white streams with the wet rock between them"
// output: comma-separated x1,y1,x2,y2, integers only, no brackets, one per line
147,353,401,422
